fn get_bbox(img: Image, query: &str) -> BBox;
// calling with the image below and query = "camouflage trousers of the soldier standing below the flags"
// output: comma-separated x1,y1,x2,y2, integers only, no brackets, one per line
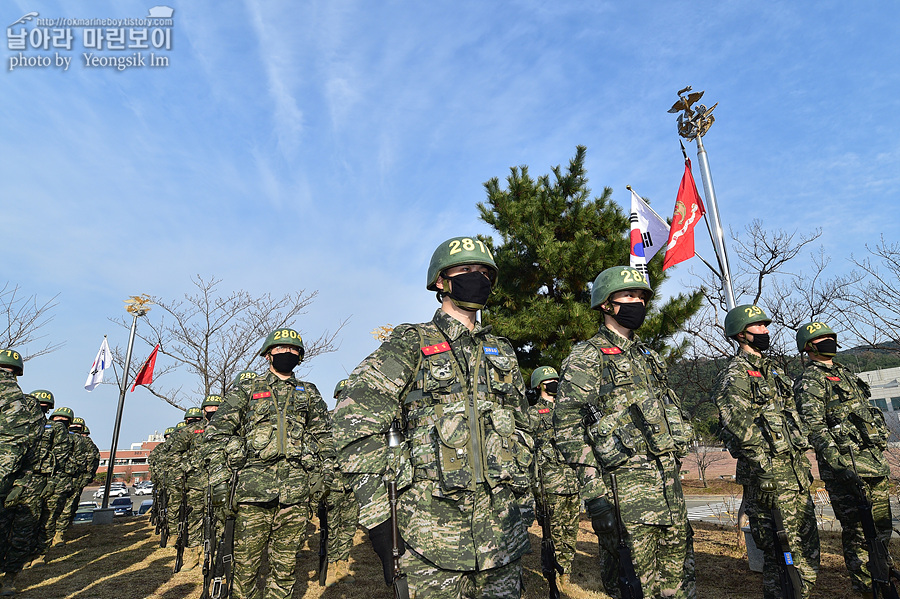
600,509,697,599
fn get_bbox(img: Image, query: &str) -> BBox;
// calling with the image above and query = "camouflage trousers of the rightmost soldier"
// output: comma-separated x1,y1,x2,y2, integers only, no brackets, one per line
825,477,892,591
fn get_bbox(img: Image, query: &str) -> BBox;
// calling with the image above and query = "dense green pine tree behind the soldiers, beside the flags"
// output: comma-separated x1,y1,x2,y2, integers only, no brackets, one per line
478,146,701,380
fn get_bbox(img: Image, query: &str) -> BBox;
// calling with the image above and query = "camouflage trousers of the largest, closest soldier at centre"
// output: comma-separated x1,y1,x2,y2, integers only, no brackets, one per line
400,547,523,599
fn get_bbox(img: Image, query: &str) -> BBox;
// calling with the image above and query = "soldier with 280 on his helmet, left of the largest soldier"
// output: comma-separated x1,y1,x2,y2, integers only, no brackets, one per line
204,328,334,598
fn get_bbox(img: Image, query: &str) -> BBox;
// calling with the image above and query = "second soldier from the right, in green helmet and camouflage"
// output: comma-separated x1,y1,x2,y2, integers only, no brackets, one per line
712,304,819,599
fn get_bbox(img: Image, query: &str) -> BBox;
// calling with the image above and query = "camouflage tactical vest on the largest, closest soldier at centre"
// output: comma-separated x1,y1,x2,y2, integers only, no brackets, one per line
401,323,533,492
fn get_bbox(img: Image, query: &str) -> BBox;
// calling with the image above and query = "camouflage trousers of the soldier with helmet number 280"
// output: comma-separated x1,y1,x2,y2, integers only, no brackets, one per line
234,501,307,599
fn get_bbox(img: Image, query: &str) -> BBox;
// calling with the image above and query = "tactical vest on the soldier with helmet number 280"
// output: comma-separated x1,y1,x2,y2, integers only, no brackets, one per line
242,376,323,471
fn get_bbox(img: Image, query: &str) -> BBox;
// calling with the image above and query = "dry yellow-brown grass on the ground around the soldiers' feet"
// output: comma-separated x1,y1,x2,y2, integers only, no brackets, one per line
17,518,900,599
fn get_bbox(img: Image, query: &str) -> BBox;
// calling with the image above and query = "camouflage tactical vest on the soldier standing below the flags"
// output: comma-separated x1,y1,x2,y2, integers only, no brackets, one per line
585,336,693,469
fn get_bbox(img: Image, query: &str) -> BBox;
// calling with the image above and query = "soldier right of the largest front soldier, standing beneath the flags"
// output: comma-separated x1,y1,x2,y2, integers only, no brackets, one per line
553,266,697,598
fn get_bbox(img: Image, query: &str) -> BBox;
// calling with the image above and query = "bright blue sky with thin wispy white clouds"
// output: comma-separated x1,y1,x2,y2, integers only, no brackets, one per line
0,0,900,449
